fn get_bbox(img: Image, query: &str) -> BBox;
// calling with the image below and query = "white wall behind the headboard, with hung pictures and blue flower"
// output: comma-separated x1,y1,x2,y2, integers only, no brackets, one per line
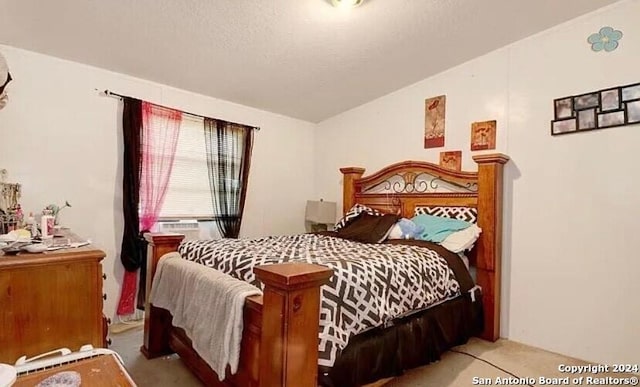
315,0,640,364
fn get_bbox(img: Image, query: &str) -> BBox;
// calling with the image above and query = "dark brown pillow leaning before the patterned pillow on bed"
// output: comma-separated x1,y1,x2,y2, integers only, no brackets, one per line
337,211,399,243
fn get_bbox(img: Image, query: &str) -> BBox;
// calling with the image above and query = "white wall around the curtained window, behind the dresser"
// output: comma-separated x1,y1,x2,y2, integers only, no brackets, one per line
0,46,314,322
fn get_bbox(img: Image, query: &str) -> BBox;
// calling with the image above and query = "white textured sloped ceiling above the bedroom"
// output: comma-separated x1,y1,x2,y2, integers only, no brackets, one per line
0,0,615,122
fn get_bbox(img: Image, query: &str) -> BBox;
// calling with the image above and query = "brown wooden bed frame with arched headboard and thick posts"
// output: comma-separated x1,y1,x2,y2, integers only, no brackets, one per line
141,154,509,387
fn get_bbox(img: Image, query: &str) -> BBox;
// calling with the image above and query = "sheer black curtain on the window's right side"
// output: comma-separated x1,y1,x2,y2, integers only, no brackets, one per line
204,118,253,238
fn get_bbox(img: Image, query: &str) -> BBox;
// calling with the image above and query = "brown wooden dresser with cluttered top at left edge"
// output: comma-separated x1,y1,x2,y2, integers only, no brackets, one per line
0,247,107,364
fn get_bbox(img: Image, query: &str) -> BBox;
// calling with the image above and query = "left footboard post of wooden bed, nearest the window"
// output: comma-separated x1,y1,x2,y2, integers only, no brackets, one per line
140,233,184,359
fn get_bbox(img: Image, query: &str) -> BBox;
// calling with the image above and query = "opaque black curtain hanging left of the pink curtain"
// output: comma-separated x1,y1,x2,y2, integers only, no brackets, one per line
120,97,146,308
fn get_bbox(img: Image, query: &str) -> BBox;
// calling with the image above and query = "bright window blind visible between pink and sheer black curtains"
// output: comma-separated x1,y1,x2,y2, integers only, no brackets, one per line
160,114,213,219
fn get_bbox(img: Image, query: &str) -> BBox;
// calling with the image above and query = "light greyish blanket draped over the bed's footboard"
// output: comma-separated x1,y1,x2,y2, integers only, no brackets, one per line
150,252,261,380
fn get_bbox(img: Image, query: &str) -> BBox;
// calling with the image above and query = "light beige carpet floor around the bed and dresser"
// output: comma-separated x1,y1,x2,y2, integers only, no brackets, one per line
110,328,632,387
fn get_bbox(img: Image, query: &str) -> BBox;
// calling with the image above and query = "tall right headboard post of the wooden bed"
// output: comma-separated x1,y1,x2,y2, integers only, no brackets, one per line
473,153,509,341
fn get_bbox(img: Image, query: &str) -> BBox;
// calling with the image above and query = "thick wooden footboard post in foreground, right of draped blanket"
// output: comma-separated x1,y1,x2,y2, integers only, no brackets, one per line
254,263,333,387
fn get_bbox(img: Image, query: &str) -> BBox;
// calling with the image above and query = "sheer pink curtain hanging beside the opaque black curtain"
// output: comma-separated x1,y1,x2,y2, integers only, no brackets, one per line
117,101,182,316
